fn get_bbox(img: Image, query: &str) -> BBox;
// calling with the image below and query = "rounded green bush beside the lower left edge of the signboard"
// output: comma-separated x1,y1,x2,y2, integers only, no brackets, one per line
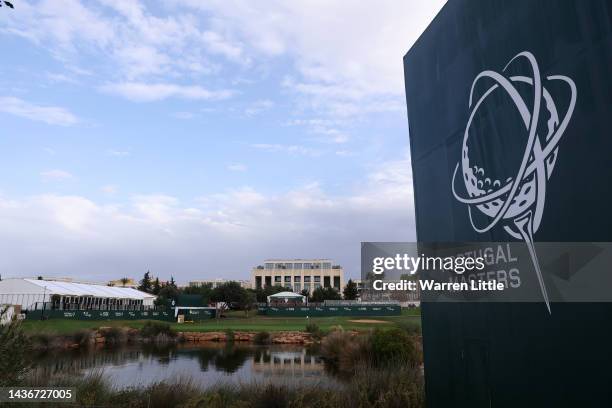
370,329,419,366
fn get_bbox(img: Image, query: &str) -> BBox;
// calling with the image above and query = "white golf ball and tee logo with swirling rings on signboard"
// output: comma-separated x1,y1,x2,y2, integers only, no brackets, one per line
452,51,577,313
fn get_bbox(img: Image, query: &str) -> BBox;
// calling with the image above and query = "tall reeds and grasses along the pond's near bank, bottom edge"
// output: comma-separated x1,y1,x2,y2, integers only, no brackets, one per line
17,364,424,408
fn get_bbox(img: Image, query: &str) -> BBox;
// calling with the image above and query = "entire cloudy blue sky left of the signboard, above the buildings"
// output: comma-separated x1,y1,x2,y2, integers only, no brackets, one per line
0,0,442,282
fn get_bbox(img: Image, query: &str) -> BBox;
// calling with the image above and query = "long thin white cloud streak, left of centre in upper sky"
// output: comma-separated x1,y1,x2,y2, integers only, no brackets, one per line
100,82,233,102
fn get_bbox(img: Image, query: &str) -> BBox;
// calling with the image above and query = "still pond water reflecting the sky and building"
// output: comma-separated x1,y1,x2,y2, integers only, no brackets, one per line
33,343,338,387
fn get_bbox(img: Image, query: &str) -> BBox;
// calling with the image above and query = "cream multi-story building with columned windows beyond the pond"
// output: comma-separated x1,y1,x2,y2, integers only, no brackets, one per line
251,259,344,293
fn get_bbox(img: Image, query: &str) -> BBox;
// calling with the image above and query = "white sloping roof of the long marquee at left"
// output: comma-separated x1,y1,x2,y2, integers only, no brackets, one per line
24,279,155,299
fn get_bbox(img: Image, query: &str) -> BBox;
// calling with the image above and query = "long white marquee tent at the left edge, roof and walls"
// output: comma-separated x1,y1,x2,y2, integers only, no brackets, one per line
0,279,155,310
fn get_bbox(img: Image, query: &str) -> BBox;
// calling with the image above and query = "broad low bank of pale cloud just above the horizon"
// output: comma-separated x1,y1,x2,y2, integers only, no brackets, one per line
0,157,415,282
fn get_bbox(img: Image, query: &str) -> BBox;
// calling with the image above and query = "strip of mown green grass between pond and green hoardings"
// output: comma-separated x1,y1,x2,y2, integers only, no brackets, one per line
22,309,421,335
